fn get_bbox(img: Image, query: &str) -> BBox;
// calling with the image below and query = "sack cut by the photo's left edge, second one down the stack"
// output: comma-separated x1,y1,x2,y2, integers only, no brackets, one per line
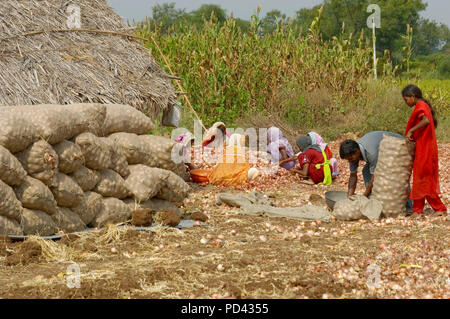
0,146,27,186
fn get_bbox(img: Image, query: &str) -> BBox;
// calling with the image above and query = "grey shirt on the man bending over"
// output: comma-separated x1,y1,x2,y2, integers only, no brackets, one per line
350,131,403,174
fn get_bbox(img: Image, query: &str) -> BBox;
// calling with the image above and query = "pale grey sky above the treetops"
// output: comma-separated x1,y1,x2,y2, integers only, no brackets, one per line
107,0,450,26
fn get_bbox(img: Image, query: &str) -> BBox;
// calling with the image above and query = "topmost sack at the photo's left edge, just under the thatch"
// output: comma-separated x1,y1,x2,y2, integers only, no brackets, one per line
0,112,38,153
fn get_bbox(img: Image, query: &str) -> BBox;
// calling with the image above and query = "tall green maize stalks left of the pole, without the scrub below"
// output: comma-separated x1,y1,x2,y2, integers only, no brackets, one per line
138,12,371,124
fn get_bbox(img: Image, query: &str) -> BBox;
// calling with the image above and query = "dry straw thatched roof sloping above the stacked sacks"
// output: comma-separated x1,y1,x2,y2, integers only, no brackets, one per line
0,0,176,114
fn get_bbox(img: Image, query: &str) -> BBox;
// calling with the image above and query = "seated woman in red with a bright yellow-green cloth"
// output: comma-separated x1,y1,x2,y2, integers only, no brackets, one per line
292,136,333,185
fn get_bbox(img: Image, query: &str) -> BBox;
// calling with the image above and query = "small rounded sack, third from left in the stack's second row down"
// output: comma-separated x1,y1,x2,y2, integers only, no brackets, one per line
53,140,84,174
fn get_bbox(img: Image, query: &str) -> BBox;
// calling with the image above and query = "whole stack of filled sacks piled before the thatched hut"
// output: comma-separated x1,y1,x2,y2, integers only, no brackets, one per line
0,104,189,236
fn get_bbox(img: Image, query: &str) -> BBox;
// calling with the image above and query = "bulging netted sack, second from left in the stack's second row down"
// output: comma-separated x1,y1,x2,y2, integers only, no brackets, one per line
16,140,59,185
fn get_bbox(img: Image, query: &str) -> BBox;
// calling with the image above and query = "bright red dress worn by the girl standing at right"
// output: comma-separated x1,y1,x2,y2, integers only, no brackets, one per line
405,101,445,209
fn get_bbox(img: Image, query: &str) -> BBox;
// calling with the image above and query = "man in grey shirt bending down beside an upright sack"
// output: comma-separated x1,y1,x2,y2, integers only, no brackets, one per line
339,131,412,211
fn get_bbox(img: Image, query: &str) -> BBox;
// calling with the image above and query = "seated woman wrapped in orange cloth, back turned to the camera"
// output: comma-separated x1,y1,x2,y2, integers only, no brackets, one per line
208,134,259,186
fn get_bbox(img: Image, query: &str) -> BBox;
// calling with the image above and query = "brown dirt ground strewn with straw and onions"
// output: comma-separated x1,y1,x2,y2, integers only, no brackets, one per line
0,144,450,299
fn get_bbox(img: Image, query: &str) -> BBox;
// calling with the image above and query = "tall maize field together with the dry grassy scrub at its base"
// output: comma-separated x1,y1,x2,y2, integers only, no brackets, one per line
136,11,445,138
